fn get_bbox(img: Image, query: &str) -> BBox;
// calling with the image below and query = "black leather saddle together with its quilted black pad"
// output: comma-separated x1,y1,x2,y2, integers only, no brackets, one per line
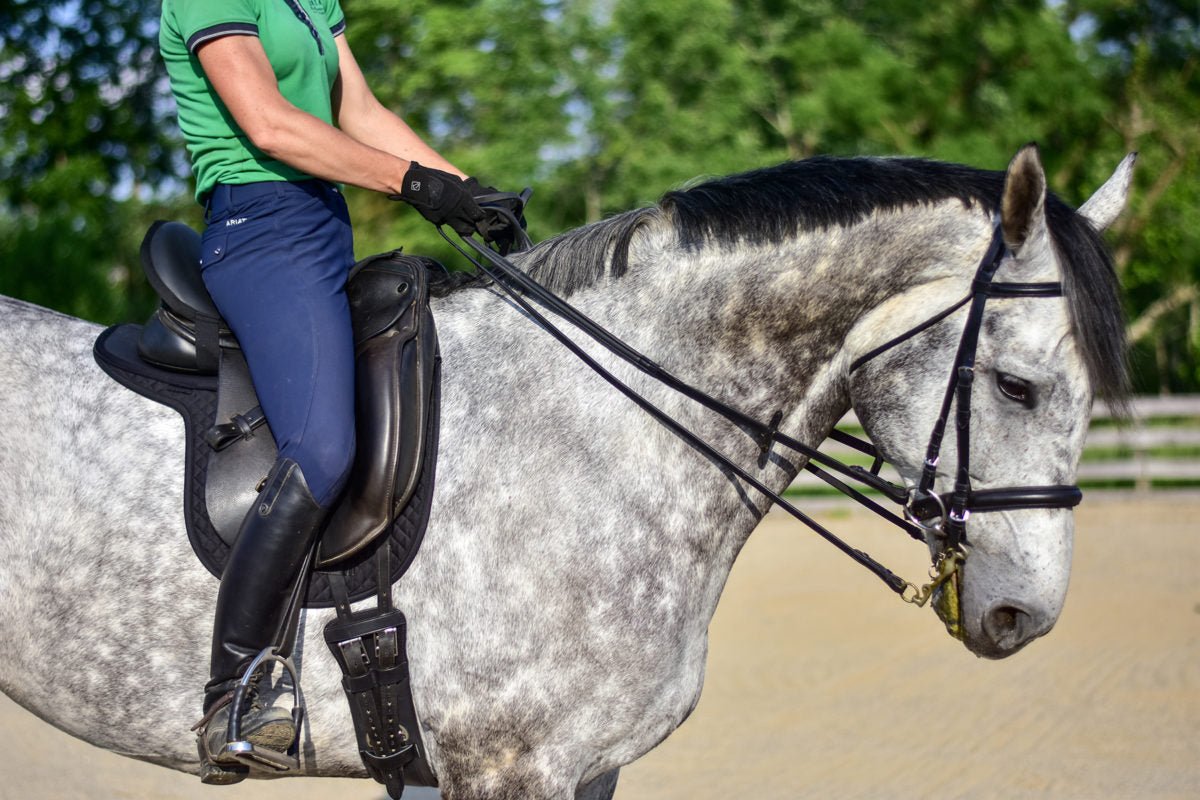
94,222,445,606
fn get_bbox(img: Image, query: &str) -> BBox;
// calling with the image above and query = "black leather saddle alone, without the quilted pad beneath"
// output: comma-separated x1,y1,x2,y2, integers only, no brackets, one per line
110,222,445,570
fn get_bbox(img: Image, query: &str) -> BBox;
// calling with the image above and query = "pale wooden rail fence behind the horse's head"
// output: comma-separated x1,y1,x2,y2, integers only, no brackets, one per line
792,395,1200,492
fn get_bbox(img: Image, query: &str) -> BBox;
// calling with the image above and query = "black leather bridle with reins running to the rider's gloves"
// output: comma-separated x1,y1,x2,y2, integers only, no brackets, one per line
442,200,1082,606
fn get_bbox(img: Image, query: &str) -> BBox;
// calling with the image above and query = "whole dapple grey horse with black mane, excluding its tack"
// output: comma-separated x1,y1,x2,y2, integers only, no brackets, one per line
0,148,1132,800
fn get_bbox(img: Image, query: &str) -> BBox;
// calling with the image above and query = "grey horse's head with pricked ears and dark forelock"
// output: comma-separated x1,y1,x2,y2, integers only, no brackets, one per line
850,145,1134,658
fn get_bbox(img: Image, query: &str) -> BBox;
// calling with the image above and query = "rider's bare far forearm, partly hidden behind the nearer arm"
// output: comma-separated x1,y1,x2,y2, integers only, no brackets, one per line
332,34,467,178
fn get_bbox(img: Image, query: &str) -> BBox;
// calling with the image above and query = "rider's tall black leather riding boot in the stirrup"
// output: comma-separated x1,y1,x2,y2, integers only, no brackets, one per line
199,458,326,783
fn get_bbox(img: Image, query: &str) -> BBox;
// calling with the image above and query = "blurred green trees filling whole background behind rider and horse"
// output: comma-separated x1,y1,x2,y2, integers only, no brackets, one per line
0,0,1200,391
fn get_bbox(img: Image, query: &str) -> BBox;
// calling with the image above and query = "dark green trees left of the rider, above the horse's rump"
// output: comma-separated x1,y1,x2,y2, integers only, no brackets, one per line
0,0,181,320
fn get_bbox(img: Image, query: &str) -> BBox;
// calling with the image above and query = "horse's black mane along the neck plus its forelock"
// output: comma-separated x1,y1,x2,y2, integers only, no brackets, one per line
527,157,1129,409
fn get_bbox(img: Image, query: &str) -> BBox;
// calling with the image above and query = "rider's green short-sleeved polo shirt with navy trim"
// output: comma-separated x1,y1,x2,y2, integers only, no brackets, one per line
158,0,346,199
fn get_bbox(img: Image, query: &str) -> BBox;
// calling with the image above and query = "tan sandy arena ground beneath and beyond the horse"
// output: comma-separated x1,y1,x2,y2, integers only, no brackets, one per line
0,494,1200,800
